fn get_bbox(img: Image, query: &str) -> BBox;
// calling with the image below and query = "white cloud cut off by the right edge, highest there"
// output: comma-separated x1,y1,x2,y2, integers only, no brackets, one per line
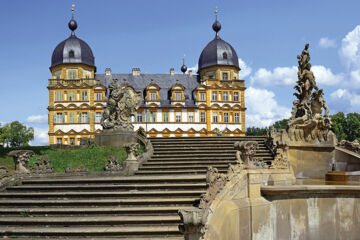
339,25,360,71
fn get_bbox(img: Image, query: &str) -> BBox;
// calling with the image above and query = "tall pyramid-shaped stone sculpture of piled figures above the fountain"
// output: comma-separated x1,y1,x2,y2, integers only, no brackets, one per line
288,44,331,141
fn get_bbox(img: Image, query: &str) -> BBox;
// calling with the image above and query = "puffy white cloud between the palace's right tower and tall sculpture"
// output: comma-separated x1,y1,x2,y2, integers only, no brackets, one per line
245,87,291,127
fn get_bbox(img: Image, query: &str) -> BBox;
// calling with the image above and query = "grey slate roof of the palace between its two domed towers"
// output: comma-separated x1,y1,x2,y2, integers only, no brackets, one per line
95,73,200,107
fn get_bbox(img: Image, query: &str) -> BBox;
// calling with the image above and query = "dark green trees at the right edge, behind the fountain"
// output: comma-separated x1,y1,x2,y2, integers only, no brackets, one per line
330,112,360,141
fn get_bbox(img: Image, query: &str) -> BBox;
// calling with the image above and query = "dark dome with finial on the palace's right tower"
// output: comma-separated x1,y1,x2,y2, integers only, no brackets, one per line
198,7,240,78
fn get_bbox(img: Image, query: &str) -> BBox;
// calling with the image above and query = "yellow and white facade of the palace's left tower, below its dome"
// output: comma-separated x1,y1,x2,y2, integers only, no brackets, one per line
48,64,106,145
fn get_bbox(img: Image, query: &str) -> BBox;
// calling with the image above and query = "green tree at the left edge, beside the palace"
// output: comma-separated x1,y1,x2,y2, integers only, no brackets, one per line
0,121,34,147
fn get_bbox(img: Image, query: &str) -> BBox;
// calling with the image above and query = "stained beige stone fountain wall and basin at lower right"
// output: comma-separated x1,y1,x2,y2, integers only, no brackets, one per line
202,169,360,240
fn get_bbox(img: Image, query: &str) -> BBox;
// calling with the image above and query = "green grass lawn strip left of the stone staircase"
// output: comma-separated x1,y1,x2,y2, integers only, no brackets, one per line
0,146,127,174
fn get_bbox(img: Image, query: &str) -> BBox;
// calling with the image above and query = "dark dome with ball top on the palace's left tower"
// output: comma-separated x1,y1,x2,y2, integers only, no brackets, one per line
51,18,95,67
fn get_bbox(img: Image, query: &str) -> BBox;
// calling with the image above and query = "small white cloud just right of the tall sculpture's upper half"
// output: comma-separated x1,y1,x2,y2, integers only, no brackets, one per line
311,65,344,86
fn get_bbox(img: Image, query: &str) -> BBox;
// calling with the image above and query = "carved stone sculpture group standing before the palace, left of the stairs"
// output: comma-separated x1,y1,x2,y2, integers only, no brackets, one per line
101,79,143,131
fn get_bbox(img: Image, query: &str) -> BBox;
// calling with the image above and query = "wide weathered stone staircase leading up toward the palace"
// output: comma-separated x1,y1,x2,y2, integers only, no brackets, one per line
0,137,272,240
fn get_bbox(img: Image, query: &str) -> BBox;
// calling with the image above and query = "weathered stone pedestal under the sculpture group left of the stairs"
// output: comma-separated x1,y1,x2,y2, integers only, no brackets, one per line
95,129,137,147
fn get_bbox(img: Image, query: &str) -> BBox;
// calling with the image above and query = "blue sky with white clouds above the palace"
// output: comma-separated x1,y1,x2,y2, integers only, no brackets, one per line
0,0,360,144
